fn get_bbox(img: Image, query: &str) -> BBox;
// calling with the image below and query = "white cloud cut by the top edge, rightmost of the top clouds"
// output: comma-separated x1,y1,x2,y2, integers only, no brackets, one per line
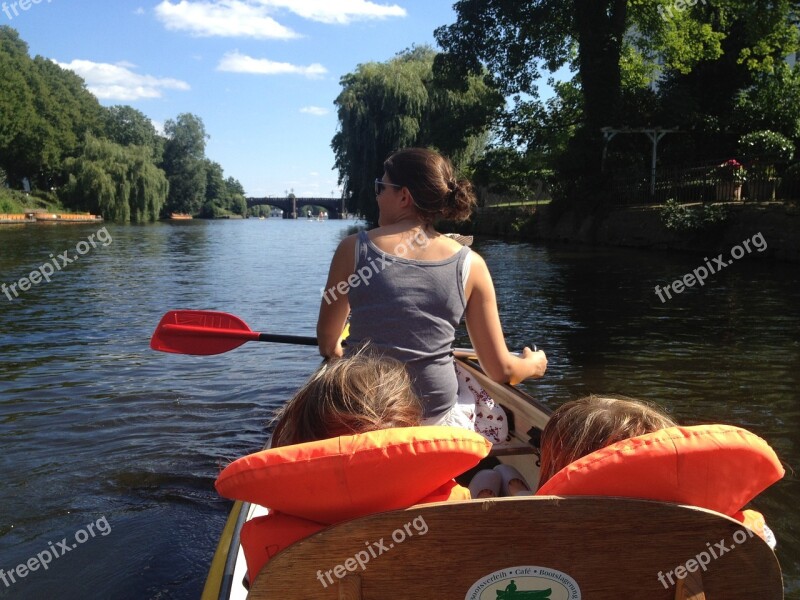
256,0,406,25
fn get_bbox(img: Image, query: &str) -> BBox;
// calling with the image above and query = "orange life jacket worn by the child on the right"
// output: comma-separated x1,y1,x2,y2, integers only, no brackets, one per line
536,425,784,537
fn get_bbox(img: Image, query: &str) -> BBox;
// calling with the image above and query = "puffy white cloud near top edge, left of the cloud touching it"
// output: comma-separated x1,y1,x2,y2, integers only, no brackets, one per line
155,0,299,40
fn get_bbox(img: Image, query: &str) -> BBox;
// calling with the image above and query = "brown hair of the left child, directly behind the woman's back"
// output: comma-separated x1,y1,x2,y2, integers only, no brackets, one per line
272,348,422,447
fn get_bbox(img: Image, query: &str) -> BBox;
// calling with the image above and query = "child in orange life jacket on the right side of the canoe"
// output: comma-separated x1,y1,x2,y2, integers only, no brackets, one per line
537,395,783,549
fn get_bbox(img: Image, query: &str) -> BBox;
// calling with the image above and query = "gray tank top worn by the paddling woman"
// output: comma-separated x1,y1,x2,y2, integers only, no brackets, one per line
347,231,470,418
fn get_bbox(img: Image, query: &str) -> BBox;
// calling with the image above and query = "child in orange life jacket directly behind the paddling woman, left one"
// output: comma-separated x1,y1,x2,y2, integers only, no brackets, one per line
216,348,491,579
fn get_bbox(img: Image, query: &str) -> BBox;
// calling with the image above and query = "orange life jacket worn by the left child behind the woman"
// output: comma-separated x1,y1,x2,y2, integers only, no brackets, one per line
216,426,492,577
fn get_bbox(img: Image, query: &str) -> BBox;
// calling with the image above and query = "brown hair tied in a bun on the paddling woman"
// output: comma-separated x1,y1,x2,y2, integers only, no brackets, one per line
383,148,476,222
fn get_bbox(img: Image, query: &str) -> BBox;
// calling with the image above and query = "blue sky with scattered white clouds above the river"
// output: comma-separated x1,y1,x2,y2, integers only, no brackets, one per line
0,0,462,197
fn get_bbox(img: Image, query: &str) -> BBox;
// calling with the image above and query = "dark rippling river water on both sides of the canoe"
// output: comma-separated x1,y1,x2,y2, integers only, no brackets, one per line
0,219,800,600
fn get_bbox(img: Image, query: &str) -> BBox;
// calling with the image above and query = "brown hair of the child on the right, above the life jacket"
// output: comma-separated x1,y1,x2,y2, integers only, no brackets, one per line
539,395,676,487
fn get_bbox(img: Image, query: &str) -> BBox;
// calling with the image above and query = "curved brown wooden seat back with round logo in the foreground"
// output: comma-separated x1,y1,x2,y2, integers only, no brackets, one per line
248,496,783,600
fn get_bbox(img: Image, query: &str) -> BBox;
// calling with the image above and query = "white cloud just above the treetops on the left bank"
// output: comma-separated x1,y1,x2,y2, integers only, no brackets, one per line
56,60,190,102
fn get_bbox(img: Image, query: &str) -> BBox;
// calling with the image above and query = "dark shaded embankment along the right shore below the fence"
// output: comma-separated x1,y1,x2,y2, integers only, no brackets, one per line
468,202,800,262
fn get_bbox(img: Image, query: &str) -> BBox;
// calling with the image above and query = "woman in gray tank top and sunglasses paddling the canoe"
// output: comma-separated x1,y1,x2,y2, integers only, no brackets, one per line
317,148,547,429
